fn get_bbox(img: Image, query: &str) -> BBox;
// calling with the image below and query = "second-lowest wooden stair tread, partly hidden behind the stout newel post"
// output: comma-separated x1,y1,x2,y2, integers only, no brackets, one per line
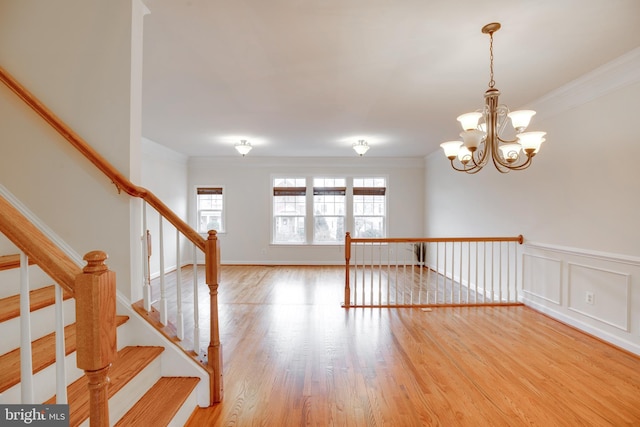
44,346,164,426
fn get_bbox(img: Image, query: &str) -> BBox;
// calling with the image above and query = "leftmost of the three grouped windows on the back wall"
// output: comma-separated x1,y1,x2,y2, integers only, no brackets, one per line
273,178,307,243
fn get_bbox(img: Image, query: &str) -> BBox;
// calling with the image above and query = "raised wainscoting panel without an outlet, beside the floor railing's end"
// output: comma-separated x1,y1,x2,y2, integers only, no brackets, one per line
522,253,562,305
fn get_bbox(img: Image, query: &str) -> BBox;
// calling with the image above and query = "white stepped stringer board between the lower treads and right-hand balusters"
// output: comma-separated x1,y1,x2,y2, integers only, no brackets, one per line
116,291,210,407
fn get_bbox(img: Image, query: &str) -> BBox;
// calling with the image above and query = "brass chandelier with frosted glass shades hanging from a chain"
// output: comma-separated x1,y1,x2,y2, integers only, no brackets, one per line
440,22,546,174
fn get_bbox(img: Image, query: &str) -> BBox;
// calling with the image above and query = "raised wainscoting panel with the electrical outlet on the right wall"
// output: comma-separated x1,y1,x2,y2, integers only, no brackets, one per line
567,262,631,332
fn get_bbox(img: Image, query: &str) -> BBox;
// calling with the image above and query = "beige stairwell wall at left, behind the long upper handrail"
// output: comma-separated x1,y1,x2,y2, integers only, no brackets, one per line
0,0,132,295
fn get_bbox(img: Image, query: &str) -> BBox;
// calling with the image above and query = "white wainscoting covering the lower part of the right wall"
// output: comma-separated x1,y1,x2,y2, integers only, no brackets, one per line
521,242,640,355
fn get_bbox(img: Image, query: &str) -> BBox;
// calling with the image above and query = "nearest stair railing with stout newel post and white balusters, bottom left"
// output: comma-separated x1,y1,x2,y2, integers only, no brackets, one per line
0,196,117,427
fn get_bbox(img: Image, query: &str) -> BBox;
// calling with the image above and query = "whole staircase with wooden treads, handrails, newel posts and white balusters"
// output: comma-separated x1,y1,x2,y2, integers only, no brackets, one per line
0,67,223,426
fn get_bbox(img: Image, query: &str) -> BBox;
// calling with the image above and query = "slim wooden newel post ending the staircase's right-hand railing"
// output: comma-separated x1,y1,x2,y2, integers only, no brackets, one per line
205,230,223,404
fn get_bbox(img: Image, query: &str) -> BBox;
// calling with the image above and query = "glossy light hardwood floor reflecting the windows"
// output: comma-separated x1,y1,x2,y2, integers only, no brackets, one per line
154,266,640,426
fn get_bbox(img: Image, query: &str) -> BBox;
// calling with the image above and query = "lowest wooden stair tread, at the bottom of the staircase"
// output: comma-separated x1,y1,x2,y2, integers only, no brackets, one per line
116,377,200,426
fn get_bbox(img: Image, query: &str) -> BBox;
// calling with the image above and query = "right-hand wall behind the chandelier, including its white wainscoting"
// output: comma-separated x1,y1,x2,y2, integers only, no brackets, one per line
425,49,640,352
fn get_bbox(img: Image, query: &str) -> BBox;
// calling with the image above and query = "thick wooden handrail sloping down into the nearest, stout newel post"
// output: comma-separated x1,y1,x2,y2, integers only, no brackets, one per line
0,197,82,295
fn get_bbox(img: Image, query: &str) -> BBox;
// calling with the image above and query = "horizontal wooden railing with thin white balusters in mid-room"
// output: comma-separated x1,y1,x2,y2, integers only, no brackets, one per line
343,233,523,308
